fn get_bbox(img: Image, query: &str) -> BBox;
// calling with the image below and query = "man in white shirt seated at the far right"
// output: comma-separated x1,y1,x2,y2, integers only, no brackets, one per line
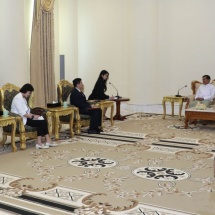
189,75,215,107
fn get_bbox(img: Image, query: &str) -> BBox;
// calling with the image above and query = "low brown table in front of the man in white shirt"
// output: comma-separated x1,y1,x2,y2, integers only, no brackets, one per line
184,108,215,128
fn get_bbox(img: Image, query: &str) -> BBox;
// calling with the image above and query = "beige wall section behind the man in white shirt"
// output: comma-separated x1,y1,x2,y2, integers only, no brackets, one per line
158,0,215,98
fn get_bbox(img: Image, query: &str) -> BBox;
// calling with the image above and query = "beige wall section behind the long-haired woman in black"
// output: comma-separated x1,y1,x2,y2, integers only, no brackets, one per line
78,0,128,98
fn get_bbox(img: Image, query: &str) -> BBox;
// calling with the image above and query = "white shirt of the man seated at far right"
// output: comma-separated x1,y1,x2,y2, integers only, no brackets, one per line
195,84,215,100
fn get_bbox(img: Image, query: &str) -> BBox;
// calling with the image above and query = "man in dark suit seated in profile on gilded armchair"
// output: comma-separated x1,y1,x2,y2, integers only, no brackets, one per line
70,78,102,134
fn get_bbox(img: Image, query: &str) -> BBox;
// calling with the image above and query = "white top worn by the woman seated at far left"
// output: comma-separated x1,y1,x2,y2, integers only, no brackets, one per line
11,93,30,125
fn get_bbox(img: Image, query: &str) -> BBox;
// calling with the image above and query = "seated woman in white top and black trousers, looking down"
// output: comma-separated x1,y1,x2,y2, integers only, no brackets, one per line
11,84,57,149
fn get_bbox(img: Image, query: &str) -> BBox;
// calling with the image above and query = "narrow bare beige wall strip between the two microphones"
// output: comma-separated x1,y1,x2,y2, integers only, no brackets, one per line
127,0,160,104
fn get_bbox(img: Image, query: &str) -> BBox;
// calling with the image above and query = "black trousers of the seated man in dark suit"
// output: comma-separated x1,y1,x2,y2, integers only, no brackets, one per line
79,109,102,130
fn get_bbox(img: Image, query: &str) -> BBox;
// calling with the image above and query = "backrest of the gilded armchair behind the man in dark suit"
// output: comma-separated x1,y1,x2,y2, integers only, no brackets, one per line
57,80,74,104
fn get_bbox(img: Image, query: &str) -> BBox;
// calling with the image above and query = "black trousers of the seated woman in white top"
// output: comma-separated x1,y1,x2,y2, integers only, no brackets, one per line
26,118,49,136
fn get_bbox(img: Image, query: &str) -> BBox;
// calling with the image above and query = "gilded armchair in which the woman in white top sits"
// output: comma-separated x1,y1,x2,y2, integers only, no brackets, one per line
0,83,51,149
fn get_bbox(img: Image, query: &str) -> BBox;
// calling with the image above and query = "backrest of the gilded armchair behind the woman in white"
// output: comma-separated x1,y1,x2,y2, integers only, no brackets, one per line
0,83,33,111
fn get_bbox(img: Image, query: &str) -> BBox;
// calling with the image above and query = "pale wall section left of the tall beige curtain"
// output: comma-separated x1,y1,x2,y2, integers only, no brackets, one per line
0,0,33,86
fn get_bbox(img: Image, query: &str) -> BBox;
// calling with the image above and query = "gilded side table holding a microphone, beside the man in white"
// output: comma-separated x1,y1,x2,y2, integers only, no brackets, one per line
162,96,185,120
